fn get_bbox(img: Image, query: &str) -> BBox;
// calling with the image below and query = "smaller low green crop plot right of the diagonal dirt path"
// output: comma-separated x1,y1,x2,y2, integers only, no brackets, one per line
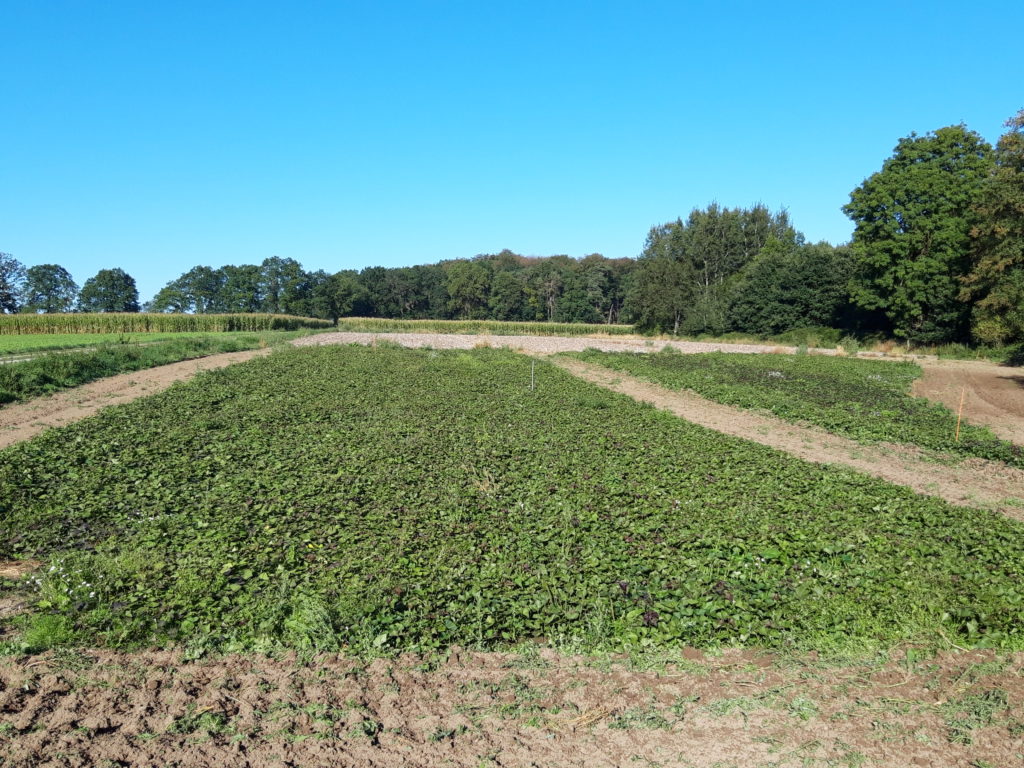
567,349,1024,467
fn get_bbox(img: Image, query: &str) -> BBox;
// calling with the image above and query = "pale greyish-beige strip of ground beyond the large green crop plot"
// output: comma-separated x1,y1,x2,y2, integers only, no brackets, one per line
292,331,836,354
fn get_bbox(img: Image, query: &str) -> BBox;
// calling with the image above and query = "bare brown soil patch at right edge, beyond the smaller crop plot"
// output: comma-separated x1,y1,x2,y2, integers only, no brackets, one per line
913,360,1024,445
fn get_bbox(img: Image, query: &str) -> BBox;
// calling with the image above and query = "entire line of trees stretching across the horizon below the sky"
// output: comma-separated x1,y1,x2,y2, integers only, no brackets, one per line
0,110,1024,344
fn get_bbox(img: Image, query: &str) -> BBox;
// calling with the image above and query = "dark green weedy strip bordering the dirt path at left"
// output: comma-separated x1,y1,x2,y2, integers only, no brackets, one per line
0,331,309,406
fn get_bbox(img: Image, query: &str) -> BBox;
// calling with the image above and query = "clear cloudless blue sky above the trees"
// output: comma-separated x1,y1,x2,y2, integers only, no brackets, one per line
0,0,1024,299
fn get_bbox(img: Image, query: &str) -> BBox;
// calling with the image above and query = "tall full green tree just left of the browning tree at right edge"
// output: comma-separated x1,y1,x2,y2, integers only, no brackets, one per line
843,125,992,343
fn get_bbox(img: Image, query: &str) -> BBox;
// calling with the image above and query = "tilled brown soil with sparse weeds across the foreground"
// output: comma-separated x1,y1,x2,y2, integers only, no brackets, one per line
0,649,1024,768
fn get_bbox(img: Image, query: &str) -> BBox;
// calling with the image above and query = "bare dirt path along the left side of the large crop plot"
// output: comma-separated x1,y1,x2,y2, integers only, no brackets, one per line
0,349,270,450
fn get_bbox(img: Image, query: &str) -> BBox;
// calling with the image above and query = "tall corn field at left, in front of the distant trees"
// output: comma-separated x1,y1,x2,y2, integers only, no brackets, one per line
0,312,334,336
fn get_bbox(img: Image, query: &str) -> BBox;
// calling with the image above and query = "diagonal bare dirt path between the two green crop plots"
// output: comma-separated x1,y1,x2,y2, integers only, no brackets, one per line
551,357,1024,520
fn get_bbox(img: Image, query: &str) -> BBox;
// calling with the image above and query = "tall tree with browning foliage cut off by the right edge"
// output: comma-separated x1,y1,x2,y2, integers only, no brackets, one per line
961,110,1024,344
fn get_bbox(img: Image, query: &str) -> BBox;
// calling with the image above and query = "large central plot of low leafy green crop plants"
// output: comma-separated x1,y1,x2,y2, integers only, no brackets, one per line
0,347,1024,652
